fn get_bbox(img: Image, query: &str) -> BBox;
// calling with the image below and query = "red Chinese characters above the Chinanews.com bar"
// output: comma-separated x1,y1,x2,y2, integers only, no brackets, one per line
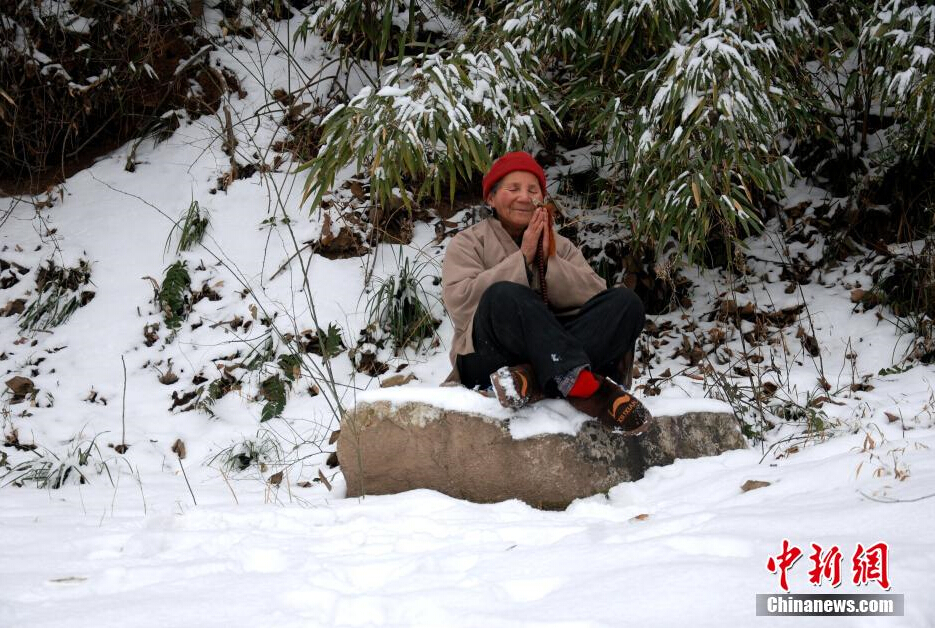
766,539,890,592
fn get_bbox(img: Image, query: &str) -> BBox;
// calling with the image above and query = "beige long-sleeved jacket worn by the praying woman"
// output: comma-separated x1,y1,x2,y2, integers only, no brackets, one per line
442,218,607,381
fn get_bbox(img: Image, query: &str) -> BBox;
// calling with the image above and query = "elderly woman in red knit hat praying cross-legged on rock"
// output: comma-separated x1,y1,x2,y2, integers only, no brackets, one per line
442,152,651,433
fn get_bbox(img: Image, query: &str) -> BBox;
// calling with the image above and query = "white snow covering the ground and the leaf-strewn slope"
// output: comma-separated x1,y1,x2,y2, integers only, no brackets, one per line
0,11,935,628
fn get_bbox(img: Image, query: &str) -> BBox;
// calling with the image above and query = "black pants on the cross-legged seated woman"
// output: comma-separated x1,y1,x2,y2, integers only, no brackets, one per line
457,281,646,395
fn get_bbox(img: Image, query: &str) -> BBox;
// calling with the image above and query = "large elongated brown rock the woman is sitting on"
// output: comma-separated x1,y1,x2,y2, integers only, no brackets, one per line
337,401,746,508
